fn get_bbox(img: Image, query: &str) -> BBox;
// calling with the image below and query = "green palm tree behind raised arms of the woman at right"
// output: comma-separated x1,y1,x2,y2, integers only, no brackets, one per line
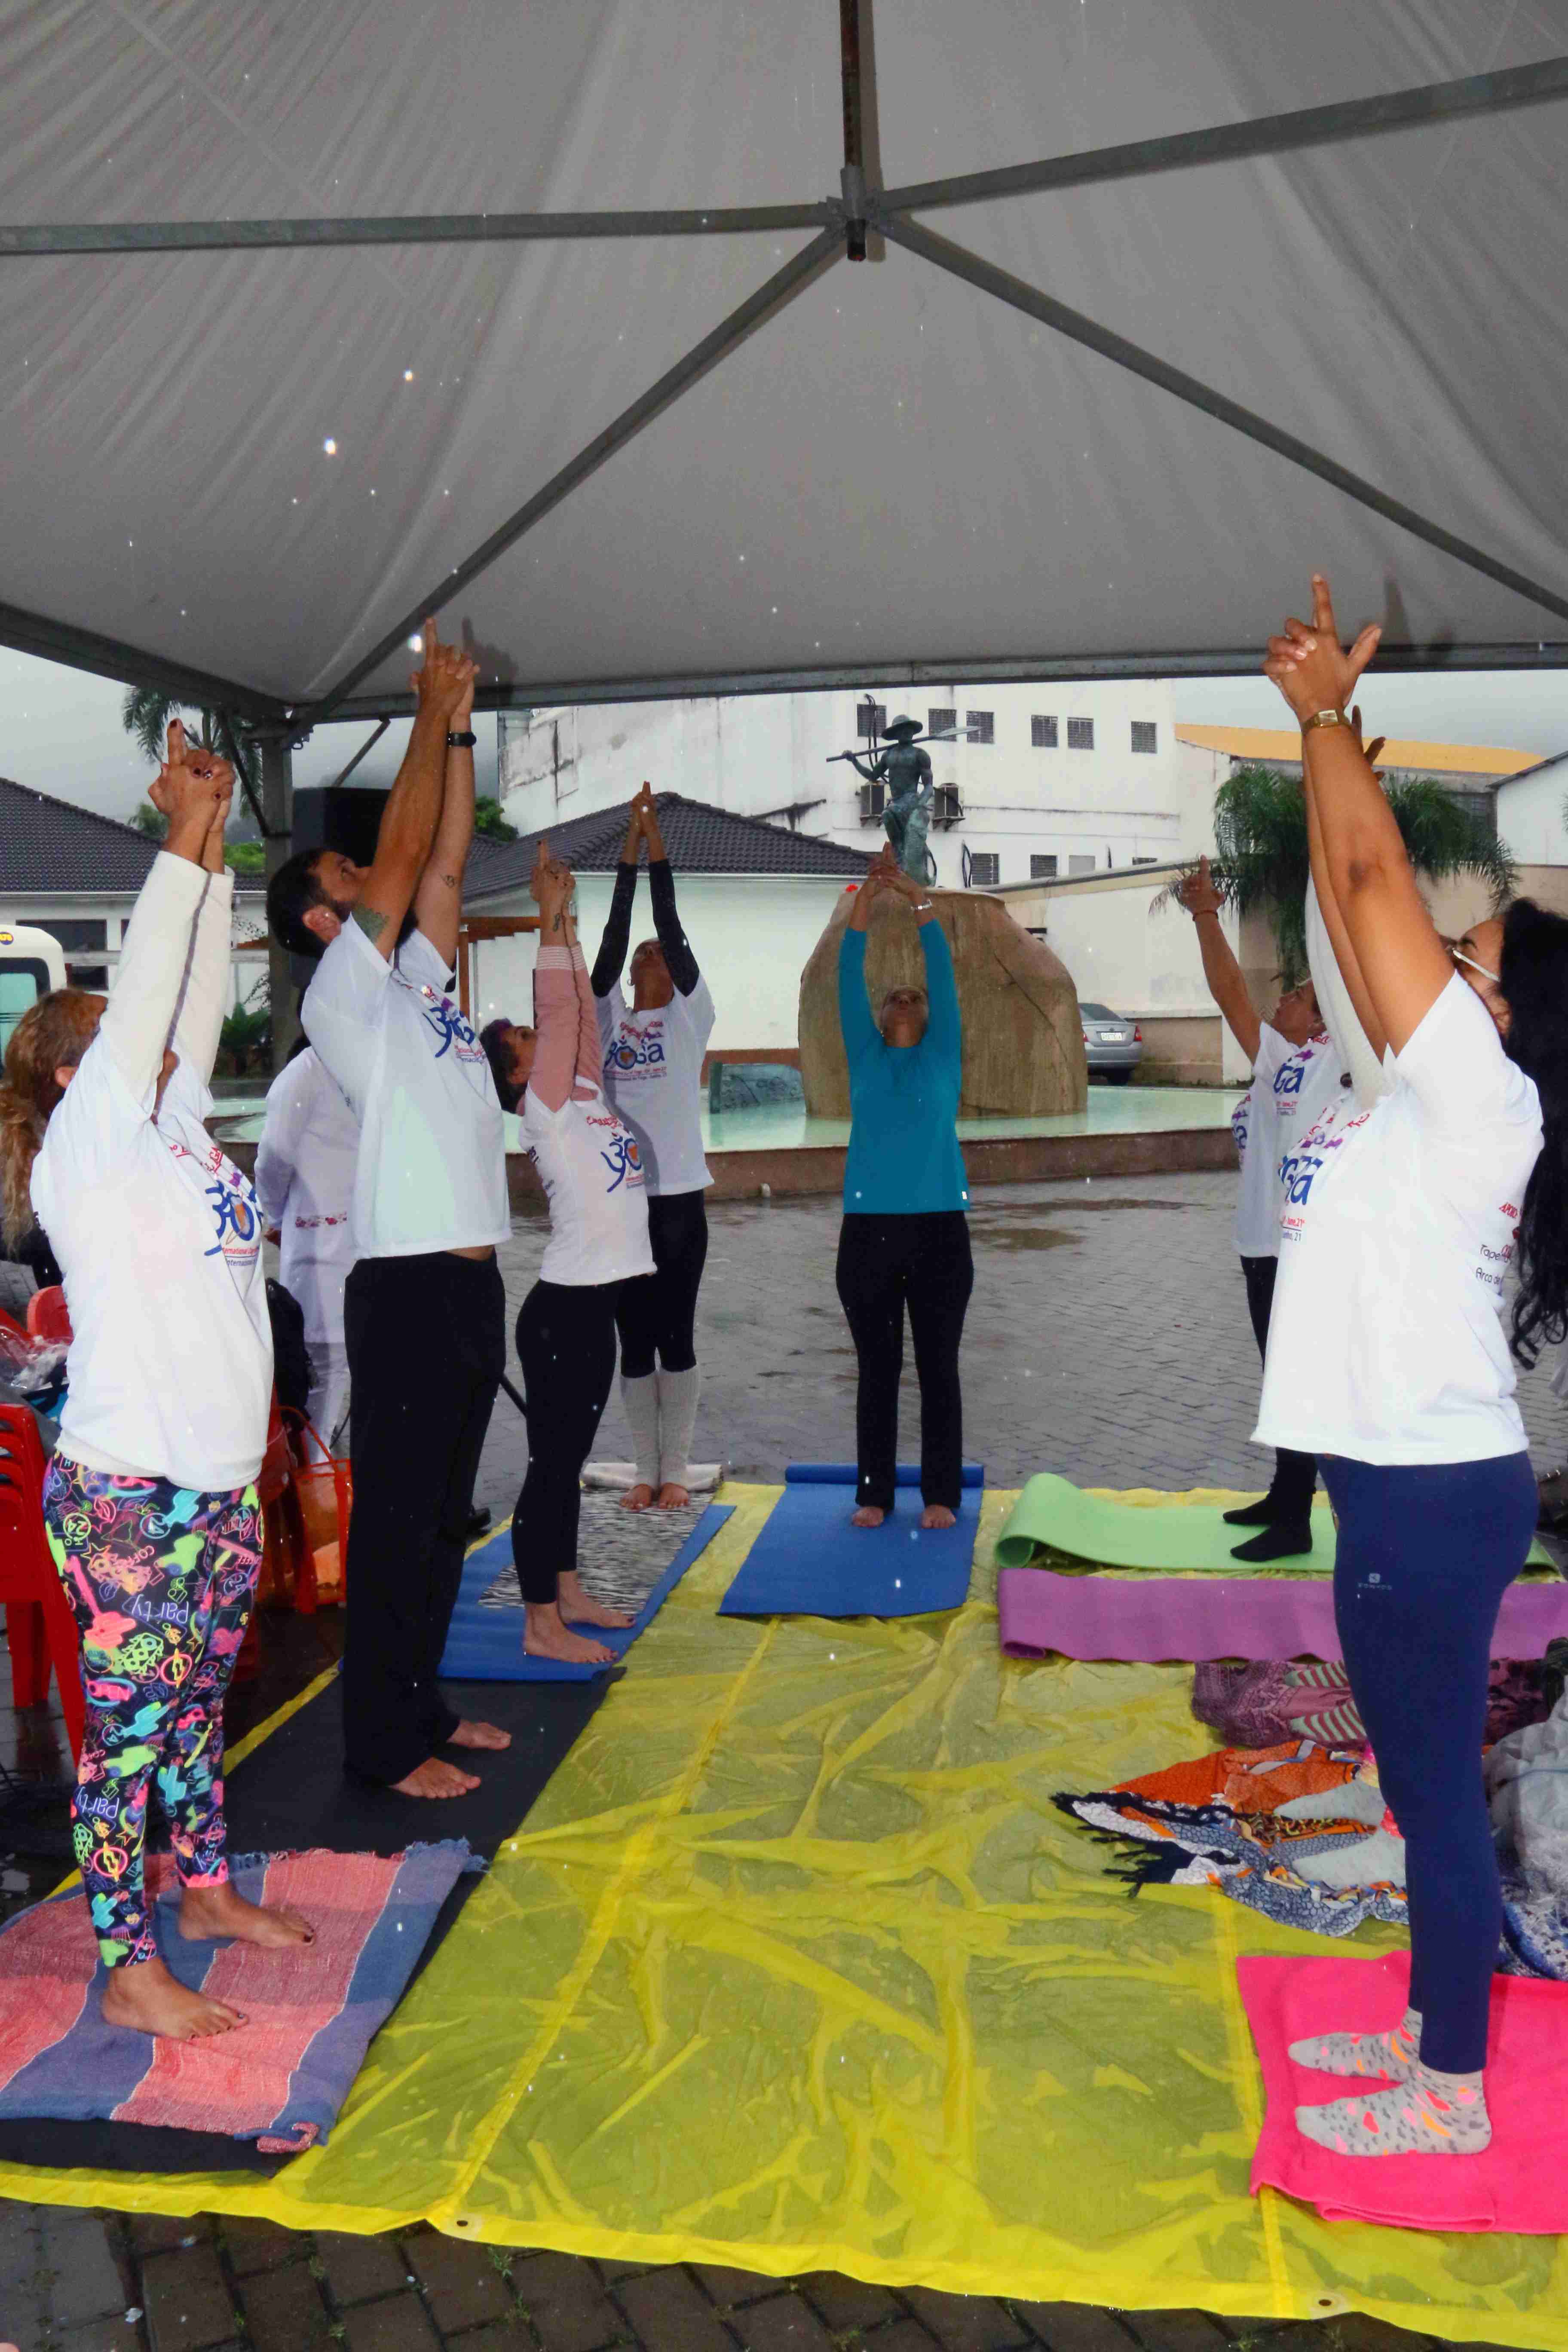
1157,767,1516,986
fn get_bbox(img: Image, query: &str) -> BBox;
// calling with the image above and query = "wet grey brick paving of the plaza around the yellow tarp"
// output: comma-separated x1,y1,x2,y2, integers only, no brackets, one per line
0,1176,1568,2352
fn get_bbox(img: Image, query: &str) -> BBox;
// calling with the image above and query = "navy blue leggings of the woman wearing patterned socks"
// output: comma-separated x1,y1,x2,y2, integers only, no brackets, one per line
1323,1454,1537,2074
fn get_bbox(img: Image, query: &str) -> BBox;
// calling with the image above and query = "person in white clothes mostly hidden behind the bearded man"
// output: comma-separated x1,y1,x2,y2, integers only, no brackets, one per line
256,1042,360,1449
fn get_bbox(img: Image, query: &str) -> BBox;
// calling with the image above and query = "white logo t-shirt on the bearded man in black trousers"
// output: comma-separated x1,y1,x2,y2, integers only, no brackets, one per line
299,922,512,1259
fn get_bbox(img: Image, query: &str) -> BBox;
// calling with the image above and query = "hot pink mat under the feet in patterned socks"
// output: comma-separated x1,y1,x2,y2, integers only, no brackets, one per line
1237,1952,1568,2237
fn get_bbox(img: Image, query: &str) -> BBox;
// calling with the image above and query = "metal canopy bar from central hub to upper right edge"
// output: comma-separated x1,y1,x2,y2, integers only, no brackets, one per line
879,56,1568,211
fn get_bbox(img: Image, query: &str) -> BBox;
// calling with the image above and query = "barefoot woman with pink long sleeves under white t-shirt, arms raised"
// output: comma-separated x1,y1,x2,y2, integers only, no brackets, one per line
484,842,653,1665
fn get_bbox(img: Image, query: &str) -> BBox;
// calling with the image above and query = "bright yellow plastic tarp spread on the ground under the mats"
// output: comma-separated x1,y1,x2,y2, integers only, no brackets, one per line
0,1486,1568,2352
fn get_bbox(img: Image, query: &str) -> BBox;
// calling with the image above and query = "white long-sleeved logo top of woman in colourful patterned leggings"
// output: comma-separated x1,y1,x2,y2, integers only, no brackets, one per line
33,851,273,1494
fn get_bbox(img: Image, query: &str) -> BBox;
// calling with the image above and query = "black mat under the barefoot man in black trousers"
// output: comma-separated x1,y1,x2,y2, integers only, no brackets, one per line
0,1675,621,2176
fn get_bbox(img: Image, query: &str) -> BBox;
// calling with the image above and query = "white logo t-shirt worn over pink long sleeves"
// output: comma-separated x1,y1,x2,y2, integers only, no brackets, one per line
522,1080,653,1286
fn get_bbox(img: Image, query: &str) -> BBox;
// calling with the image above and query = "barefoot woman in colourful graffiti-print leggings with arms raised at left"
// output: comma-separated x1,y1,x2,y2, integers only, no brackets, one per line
0,724,310,2042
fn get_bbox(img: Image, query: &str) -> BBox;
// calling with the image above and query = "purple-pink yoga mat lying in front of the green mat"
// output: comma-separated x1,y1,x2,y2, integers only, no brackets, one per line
997,1569,1568,1665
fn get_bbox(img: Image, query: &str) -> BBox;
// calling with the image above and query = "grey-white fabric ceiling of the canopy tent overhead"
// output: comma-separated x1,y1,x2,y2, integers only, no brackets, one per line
0,0,1568,713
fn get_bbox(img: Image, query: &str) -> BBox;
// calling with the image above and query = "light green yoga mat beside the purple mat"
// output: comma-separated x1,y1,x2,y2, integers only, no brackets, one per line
997,1470,1556,1576
